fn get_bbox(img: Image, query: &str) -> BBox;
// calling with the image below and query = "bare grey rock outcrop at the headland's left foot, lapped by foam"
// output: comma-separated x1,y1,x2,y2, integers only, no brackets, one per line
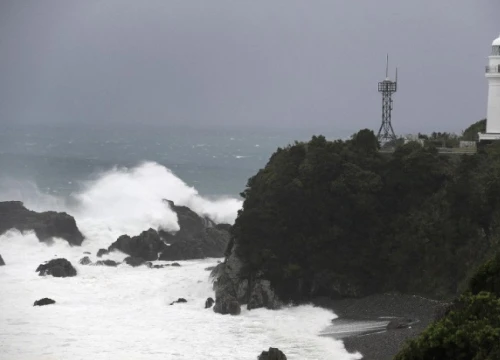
211,245,282,314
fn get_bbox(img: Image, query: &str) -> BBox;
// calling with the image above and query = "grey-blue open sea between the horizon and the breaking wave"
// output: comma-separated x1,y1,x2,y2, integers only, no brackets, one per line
0,124,349,196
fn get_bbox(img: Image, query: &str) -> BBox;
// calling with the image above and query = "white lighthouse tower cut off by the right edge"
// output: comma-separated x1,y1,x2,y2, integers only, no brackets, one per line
479,36,500,140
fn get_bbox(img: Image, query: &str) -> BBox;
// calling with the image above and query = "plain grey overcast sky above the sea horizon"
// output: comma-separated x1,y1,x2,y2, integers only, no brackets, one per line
0,0,500,133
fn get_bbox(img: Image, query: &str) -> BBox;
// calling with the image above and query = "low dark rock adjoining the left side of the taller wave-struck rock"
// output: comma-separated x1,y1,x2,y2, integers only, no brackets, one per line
108,229,167,261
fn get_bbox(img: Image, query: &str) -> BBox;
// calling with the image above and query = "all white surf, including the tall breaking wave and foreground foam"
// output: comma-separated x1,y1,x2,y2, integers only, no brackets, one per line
0,163,360,360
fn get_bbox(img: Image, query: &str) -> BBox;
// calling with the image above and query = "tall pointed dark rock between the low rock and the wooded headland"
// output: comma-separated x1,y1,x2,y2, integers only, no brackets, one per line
159,200,231,261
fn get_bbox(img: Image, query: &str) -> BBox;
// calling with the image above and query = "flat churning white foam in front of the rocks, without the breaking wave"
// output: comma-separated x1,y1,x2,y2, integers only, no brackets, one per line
0,231,360,360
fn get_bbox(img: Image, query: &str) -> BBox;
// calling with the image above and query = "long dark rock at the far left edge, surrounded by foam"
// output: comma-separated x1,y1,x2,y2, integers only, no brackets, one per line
0,201,84,246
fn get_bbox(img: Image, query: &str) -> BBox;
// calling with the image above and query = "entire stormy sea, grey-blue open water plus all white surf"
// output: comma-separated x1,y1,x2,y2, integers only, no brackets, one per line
0,122,368,360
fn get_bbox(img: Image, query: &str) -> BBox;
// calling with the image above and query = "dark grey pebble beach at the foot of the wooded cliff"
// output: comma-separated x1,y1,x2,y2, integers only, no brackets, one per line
313,293,446,360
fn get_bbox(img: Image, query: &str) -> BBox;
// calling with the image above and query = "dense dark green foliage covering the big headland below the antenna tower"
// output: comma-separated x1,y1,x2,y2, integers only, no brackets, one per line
232,130,500,301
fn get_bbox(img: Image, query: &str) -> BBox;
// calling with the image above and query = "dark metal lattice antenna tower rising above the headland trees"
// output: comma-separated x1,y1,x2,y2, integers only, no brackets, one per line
377,55,398,144
